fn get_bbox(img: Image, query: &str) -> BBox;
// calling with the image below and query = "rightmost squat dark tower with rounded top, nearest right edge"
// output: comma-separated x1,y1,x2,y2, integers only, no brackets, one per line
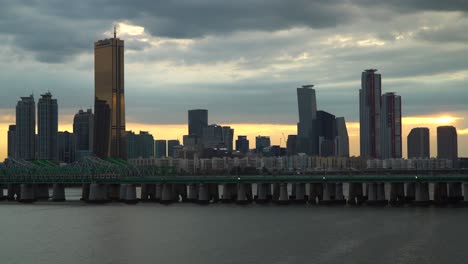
437,126,458,168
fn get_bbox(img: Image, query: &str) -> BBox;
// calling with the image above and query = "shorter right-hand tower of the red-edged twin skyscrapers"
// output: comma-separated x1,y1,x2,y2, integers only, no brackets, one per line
380,93,402,159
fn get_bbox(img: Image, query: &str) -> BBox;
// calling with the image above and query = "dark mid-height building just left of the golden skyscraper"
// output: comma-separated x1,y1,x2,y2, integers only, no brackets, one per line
73,109,94,160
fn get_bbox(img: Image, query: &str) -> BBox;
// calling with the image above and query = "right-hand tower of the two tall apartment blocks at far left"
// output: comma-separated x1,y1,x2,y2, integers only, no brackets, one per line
37,92,58,160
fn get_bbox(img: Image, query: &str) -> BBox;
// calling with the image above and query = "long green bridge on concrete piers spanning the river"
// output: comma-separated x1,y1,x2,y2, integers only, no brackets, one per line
0,157,468,205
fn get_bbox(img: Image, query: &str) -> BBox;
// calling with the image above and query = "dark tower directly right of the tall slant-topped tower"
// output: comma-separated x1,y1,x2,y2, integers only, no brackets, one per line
315,110,336,157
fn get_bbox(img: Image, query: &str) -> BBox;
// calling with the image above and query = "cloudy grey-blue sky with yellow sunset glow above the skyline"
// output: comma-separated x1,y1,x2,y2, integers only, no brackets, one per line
0,0,468,158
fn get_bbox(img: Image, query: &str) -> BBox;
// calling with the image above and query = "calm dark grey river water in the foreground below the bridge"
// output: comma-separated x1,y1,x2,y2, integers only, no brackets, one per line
0,190,468,264
